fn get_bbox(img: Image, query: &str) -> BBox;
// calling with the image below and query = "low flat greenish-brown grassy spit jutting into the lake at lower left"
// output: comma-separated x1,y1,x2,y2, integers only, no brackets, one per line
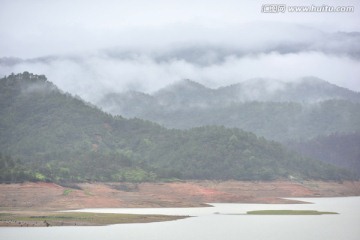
0,212,185,227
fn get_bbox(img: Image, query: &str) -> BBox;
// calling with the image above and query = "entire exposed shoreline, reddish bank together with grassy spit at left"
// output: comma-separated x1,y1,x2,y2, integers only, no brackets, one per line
0,181,360,227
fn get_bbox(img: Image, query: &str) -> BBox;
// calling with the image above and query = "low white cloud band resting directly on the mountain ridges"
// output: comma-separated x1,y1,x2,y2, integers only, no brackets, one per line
0,46,360,102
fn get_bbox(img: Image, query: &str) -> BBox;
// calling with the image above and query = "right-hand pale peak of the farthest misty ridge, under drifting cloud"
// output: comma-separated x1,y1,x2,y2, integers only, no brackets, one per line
218,77,360,103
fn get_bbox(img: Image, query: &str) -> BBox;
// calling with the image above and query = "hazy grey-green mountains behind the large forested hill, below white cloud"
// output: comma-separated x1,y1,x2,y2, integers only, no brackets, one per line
97,78,360,141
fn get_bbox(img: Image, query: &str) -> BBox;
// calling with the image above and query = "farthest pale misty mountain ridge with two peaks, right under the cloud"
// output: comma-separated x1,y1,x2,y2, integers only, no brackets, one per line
105,77,360,108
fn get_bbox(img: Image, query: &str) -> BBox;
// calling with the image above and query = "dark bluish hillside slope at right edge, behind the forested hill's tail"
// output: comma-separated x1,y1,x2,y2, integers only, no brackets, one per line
287,132,360,176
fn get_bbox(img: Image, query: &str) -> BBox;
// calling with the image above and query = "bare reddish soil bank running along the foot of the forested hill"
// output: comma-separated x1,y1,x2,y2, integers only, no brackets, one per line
0,181,360,210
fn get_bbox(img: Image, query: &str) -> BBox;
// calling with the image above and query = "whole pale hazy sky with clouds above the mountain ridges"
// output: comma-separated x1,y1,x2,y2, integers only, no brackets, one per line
0,0,360,100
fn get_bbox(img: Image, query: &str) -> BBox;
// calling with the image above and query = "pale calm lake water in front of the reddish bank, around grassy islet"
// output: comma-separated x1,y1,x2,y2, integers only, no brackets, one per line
0,197,360,240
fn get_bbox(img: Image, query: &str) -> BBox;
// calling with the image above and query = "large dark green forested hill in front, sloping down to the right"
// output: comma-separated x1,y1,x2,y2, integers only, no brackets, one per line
0,72,351,181
